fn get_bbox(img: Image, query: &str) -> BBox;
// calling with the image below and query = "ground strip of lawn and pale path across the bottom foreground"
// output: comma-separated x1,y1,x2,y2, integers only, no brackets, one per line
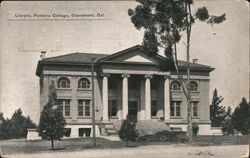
1,138,247,158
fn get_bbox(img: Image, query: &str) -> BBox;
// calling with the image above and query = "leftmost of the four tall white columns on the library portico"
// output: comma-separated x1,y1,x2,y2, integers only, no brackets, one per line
102,74,108,121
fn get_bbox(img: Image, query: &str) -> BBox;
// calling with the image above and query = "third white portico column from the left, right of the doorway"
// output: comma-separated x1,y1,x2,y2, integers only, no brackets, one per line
145,75,152,120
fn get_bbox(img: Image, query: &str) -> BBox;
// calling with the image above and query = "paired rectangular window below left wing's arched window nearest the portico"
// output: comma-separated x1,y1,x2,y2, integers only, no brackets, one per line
78,99,91,116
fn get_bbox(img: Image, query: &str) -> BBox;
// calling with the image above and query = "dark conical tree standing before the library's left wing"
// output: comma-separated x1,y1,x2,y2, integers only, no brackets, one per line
39,86,66,150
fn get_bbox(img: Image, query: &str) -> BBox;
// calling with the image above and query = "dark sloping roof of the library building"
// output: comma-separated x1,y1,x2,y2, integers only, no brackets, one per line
36,45,214,76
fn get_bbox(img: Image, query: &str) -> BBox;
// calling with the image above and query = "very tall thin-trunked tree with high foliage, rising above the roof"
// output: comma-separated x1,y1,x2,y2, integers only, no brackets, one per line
128,0,225,142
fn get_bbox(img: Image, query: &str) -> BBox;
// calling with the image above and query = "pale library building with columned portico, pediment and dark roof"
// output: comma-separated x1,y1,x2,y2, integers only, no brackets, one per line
36,45,214,137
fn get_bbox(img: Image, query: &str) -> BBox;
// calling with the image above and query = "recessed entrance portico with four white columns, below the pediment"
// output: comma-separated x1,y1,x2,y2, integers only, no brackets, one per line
101,73,170,122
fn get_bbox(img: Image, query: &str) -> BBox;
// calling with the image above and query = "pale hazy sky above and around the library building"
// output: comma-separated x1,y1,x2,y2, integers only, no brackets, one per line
0,0,249,122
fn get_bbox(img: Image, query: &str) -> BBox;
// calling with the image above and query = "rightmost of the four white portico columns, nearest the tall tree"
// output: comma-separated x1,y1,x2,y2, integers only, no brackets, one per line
164,76,170,121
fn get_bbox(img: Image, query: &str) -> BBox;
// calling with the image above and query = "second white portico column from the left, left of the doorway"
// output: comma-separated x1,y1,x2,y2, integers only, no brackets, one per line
122,74,129,119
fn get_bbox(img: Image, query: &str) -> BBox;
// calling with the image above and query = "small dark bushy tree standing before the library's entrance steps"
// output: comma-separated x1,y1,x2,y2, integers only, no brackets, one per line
119,116,138,146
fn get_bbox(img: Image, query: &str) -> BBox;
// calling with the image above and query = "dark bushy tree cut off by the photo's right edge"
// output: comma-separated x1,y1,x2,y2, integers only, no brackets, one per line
232,98,250,134
